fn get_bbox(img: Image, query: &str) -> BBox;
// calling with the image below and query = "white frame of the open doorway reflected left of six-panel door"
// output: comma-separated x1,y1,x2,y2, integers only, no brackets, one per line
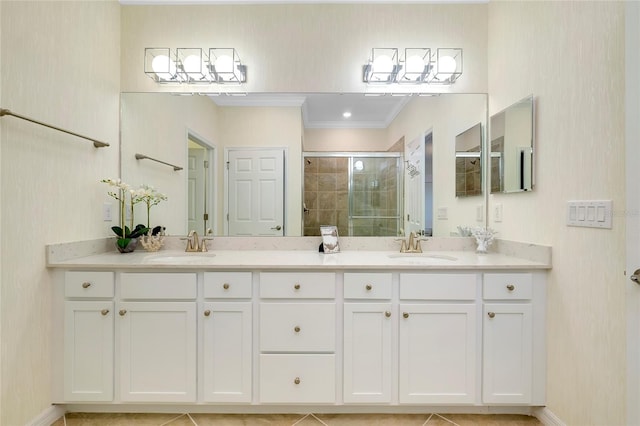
184,127,218,235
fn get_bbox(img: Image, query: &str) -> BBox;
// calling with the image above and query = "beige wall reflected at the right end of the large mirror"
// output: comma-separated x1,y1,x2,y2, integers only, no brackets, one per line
387,94,487,237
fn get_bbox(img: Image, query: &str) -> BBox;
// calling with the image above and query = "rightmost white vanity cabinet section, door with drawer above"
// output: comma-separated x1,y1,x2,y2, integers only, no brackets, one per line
482,272,544,404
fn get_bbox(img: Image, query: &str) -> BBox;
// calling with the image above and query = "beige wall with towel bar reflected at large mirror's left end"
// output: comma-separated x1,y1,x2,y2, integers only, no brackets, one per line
120,93,221,235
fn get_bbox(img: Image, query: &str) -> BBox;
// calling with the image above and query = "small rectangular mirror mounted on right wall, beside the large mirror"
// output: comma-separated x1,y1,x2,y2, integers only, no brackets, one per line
490,96,534,193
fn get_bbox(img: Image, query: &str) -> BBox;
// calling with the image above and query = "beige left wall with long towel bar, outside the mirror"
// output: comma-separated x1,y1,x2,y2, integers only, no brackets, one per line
0,1,120,425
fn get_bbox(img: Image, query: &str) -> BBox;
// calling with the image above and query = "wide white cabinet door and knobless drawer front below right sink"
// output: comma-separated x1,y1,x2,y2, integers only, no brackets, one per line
399,273,479,404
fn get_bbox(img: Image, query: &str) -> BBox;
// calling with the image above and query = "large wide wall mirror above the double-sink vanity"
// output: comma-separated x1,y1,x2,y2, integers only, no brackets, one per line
121,92,488,236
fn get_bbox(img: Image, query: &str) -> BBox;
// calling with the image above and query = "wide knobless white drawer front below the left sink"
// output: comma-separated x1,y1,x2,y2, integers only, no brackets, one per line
120,272,197,300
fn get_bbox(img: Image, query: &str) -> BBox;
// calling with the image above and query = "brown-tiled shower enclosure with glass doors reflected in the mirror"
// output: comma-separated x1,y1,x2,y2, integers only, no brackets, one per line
303,152,403,236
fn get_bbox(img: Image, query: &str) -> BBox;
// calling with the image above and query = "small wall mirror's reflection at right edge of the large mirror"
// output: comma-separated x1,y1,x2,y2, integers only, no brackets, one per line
456,123,482,197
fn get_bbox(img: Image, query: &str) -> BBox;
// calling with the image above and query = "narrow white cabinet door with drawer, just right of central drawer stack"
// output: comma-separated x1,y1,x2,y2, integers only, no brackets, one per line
342,272,395,404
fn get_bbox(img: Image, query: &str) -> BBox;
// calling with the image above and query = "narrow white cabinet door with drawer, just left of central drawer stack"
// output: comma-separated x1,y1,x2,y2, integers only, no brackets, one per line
199,272,253,403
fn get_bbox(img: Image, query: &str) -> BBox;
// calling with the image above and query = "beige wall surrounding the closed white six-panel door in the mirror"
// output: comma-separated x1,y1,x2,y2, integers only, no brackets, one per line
218,107,302,236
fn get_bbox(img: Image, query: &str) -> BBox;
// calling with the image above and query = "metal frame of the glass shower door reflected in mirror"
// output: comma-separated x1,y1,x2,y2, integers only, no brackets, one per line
301,151,404,237
